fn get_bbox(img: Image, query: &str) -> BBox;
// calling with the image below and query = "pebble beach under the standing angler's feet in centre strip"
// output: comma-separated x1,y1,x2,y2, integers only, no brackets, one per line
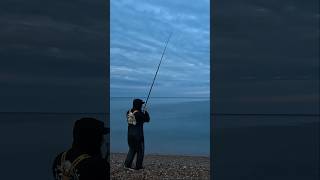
110,153,210,180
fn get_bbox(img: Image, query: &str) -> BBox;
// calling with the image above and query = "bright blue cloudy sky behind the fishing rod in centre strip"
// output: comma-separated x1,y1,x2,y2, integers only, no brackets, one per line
110,0,210,98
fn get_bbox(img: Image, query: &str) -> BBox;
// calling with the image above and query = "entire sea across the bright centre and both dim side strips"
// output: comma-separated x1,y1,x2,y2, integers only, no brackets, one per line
0,98,320,180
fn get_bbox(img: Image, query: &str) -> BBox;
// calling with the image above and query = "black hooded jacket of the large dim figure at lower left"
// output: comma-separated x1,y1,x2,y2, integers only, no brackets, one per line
52,119,110,180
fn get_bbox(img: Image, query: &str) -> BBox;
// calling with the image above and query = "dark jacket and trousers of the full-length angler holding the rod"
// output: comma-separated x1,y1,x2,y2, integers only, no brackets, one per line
125,109,150,169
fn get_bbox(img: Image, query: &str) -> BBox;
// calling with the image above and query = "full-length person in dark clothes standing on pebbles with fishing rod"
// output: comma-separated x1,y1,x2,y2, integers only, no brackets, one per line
124,99,150,170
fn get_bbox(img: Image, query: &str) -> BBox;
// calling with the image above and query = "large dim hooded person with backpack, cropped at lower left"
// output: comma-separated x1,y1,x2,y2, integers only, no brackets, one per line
52,118,110,180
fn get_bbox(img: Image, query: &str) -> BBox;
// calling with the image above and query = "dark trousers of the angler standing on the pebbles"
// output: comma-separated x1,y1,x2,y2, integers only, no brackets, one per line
125,136,144,169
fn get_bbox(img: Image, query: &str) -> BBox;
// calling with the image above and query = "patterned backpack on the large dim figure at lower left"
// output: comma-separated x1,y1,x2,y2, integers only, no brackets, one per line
57,151,90,180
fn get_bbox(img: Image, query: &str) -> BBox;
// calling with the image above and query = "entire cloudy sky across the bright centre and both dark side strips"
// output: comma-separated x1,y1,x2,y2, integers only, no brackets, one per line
0,0,320,113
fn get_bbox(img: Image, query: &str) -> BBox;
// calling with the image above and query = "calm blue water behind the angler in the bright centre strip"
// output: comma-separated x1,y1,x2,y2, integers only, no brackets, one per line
110,98,210,155
